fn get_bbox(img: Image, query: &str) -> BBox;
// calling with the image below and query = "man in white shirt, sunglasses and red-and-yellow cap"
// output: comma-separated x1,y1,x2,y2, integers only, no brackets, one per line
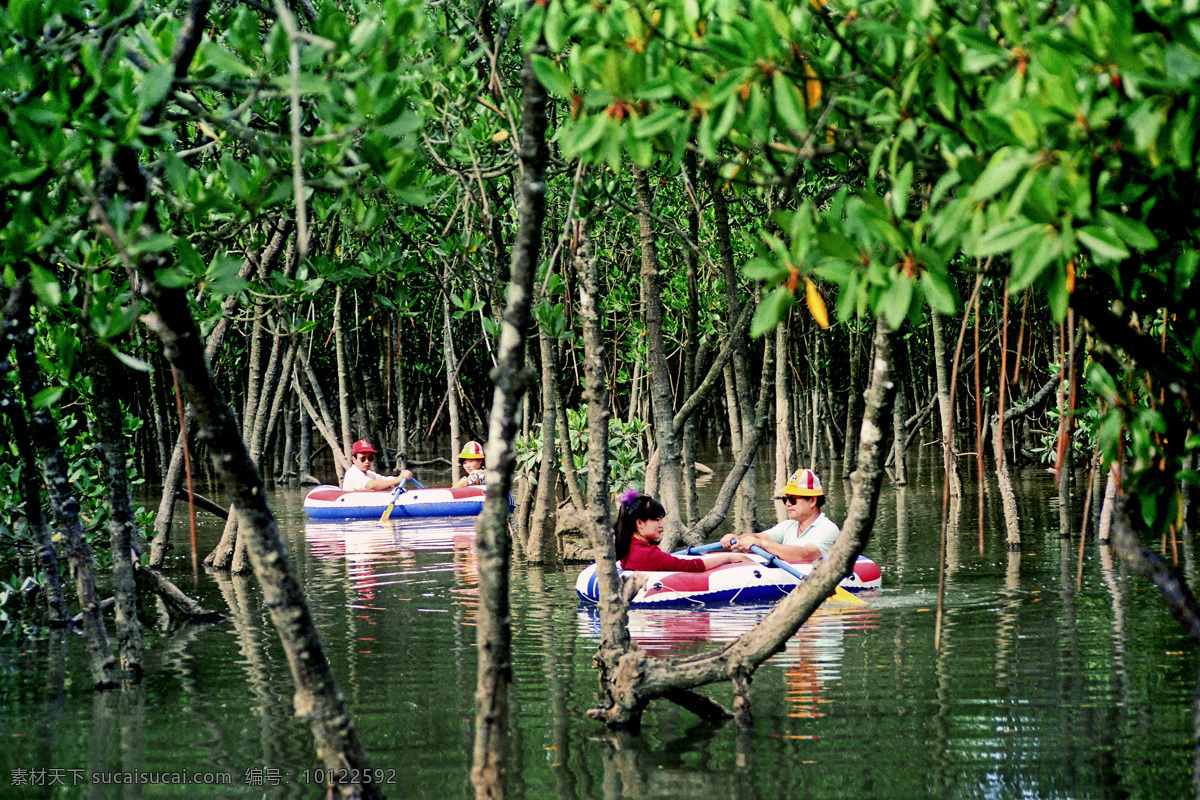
721,469,841,561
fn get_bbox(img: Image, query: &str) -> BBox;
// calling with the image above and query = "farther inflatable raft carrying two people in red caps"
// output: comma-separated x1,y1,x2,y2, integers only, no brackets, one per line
304,486,492,519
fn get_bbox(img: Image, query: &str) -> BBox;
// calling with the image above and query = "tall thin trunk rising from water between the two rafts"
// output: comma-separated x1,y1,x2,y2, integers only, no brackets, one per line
470,23,550,800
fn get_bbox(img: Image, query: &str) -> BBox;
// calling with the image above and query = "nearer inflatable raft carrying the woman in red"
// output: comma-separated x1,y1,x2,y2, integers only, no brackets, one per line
575,555,881,608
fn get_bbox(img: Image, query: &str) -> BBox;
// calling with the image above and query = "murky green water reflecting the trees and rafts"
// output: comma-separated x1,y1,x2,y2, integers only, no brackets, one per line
0,453,1198,800
